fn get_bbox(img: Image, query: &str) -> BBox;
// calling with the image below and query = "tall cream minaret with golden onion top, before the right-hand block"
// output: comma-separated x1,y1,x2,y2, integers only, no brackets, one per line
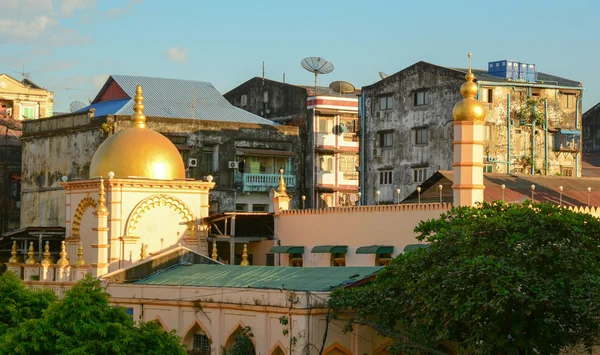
452,53,485,206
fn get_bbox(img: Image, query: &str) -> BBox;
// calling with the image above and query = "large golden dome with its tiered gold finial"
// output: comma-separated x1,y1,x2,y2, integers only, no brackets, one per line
90,85,185,180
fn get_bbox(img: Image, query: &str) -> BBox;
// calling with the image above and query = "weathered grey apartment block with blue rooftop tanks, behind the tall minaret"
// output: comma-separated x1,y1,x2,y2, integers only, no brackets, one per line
360,61,583,204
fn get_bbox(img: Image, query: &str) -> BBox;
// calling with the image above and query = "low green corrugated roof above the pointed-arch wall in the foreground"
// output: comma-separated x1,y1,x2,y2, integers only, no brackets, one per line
136,264,382,291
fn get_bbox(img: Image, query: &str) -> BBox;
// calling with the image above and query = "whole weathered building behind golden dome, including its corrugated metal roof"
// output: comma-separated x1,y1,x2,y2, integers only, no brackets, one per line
21,76,302,227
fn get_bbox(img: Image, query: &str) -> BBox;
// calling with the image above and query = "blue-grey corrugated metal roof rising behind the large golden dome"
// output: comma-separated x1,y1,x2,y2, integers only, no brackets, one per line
83,75,276,125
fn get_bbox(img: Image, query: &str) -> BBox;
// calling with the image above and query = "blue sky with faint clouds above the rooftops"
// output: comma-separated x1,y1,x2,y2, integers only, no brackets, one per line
0,0,600,112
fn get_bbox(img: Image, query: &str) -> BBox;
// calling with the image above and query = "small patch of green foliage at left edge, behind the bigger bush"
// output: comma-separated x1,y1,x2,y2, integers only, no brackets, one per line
0,272,56,336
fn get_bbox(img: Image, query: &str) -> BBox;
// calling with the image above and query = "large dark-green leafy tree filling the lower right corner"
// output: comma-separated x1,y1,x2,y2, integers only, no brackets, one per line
330,202,600,354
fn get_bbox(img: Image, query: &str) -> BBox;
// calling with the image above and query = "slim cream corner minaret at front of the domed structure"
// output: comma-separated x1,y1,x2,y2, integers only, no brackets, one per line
90,178,109,277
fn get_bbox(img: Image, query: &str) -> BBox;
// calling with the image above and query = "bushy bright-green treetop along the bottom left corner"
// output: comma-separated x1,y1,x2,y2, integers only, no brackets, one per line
0,277,186,355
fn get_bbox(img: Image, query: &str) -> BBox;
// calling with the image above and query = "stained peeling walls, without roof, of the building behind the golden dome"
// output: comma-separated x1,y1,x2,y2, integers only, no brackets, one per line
21,114,303,227
